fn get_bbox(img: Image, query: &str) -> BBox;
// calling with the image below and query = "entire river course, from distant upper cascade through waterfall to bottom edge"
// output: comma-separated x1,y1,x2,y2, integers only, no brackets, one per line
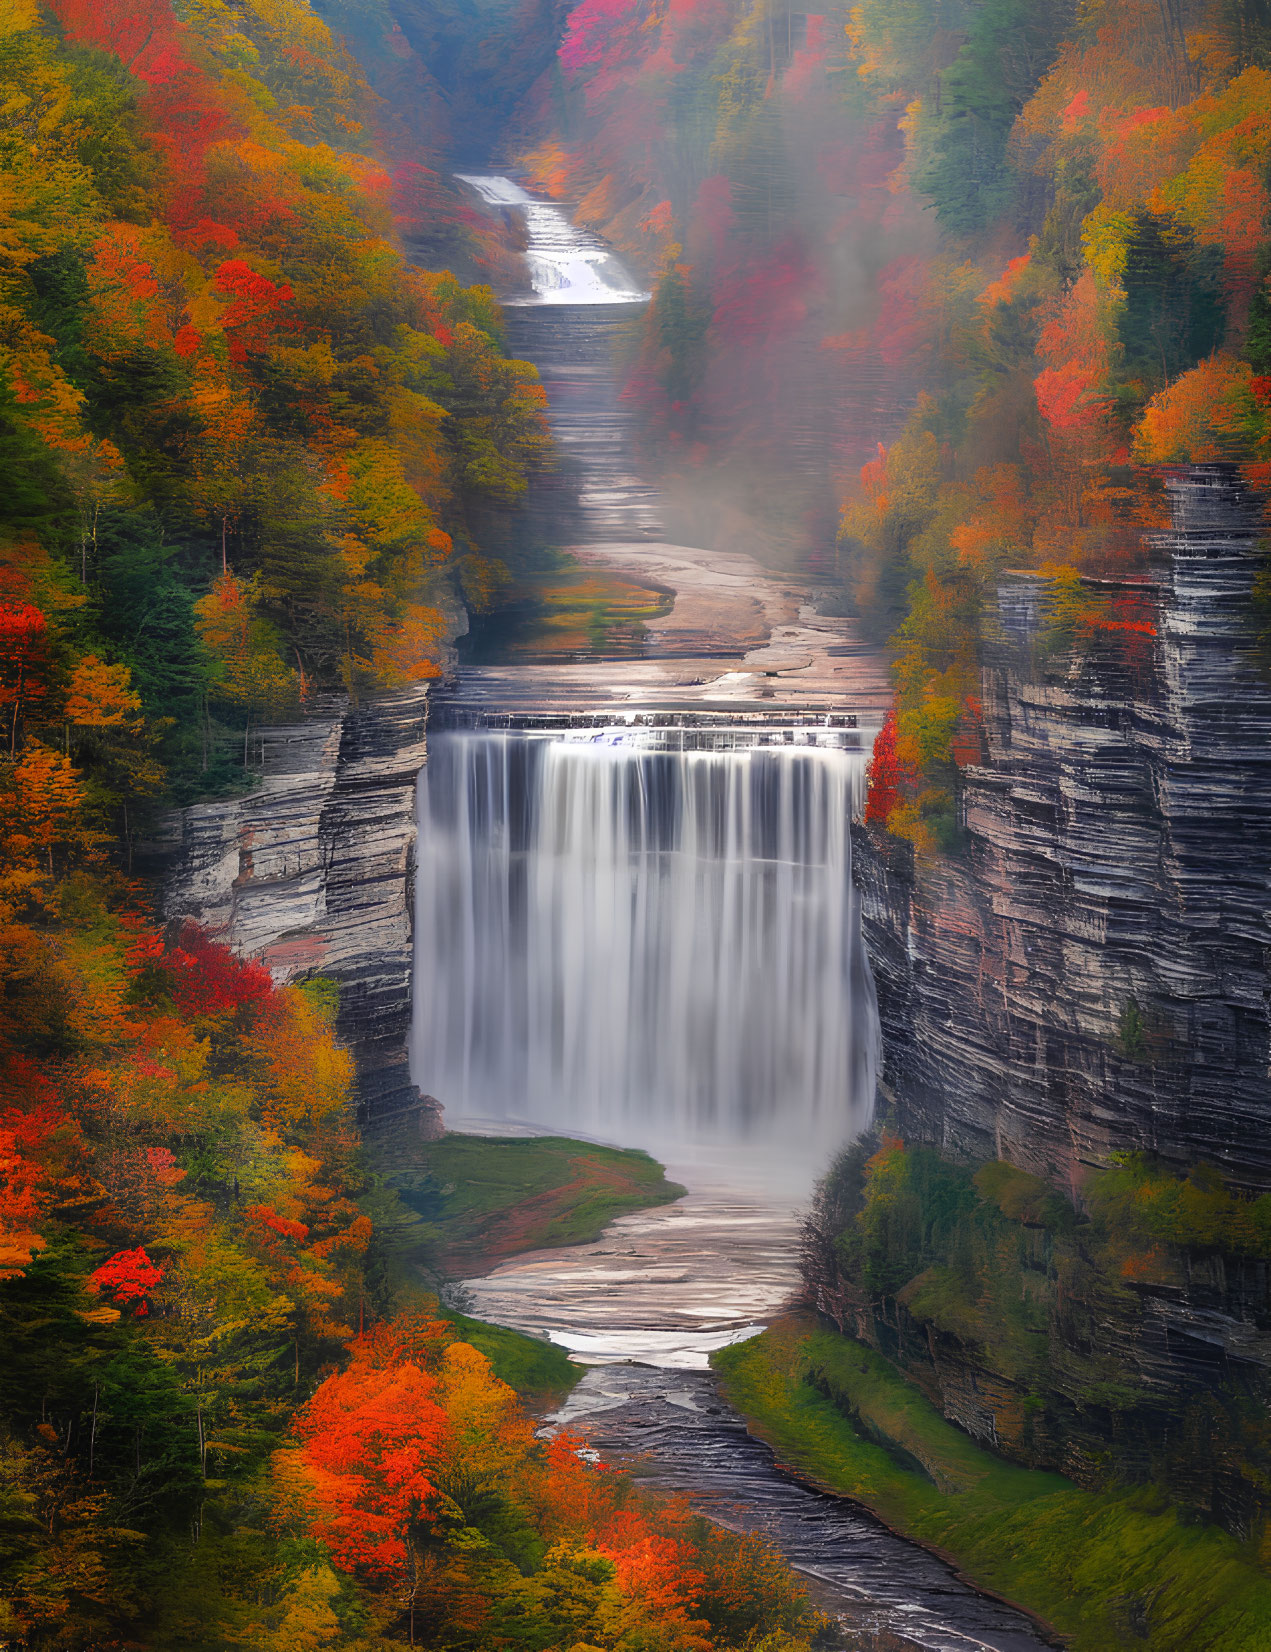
413,175,1050,1652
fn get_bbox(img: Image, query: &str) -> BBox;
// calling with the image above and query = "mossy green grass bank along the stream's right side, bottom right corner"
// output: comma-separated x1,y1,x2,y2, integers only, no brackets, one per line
712,1315,1271,1652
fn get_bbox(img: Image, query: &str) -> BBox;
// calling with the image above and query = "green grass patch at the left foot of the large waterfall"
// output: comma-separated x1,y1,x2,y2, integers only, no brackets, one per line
388,1135,684,1279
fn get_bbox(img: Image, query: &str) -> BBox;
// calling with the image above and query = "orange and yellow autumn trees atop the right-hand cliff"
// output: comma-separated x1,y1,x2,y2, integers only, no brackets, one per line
840,0,1271,832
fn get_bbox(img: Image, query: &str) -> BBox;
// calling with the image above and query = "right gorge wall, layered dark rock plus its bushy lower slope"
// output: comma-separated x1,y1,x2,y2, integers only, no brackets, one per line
805,466,1271,1535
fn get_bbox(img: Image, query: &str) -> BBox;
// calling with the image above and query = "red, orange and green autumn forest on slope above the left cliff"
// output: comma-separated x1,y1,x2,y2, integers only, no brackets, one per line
0,0,547,819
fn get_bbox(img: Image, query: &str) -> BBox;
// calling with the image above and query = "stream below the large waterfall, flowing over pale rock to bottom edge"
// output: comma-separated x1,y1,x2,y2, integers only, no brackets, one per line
463,1182,1050,1652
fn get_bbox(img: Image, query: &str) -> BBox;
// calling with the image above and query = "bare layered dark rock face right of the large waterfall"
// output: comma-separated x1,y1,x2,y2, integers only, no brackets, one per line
854,466,1271,1191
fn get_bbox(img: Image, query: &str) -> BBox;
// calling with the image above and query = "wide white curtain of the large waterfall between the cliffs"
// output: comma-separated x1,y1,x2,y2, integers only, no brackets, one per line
413,729,876,1163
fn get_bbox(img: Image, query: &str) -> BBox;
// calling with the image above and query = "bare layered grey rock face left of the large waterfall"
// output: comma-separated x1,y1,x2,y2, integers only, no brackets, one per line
162,687,440,1135
